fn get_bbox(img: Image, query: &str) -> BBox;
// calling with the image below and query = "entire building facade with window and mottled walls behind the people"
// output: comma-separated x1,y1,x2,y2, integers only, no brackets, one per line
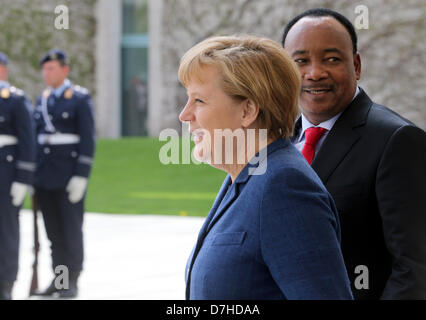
0,0,426,138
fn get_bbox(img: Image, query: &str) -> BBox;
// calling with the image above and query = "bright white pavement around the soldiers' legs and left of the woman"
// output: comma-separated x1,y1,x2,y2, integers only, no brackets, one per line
12,210,204,300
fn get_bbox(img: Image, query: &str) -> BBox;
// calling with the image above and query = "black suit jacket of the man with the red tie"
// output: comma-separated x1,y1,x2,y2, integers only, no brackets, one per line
295,90,426,299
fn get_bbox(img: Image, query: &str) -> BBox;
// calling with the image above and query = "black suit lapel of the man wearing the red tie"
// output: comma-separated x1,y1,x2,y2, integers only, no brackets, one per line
312,89,372,184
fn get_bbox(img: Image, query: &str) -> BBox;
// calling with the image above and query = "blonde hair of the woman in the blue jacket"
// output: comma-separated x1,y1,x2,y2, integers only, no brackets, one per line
178,36,301,139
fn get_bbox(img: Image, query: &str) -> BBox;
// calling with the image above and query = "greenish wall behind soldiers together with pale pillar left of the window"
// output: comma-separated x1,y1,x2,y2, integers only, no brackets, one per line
0,0,121,138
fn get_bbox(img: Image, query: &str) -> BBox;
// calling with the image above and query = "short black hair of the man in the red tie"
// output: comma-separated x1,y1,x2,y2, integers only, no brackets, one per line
281,8,358,54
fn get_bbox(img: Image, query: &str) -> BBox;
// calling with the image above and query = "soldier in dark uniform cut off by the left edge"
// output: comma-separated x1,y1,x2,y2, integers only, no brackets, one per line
0,53,36,300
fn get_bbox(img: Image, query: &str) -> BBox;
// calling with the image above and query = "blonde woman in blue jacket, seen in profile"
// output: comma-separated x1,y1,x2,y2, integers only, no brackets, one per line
179,36,352,299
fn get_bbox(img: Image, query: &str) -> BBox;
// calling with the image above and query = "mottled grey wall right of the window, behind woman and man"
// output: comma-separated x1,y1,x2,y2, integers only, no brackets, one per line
150,0,426,135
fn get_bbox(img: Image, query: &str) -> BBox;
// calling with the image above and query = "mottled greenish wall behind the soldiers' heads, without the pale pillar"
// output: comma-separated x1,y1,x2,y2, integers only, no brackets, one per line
0,0,96,112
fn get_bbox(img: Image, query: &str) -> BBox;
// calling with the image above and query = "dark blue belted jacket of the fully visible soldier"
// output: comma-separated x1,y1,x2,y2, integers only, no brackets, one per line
34,83,95,189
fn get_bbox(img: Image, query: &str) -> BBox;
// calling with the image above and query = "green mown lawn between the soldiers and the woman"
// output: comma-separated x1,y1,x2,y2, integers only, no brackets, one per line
26,138,226,216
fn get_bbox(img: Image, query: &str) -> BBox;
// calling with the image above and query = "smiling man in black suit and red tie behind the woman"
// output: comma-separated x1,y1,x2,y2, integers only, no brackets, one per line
282,9,426,299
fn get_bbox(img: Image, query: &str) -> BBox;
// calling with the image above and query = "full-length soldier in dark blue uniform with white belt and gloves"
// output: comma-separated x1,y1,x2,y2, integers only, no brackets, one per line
34,49,95,298
